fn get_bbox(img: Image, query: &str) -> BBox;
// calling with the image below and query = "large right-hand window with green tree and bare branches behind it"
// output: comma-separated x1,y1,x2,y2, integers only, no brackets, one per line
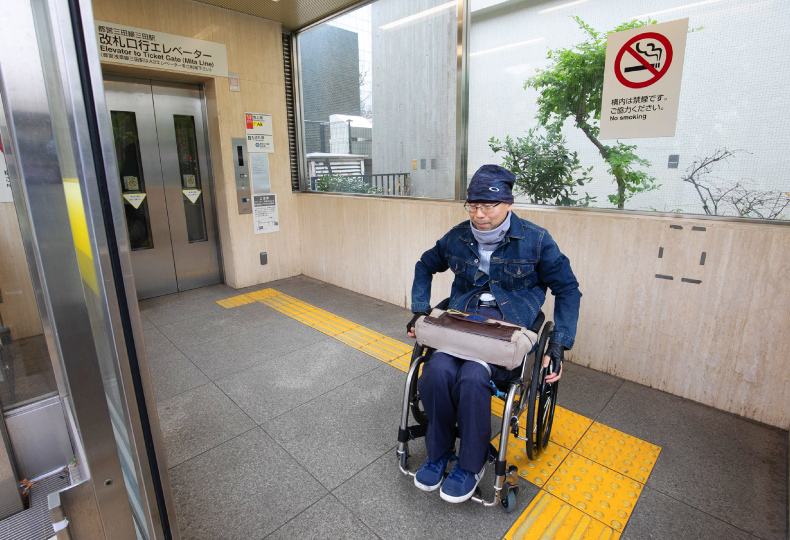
468,0,790,220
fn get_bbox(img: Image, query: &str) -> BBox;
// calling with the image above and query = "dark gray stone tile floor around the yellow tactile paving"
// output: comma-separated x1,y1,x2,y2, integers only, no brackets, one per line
140,276,788,540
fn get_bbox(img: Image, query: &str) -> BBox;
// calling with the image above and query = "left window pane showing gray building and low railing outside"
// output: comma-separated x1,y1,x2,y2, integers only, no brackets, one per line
298,0,458,199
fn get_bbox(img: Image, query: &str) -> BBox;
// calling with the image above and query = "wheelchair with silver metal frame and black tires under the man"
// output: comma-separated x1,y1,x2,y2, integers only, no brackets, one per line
397,299,560,512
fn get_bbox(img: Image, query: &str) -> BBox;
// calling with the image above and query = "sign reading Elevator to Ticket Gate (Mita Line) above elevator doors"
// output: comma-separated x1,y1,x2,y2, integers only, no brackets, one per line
96,21,228,77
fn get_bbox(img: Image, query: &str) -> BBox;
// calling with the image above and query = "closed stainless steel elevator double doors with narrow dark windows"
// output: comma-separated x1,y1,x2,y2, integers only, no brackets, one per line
105,78,220,299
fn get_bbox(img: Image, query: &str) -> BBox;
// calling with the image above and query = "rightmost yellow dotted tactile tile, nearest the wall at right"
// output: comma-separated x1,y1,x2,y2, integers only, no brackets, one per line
574,422,661,484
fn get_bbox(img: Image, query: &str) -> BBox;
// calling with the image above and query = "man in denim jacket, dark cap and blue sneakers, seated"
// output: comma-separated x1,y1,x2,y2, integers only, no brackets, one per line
406,165,581,503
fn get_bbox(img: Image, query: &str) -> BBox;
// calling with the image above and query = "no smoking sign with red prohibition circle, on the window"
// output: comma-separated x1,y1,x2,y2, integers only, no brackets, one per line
599,19,688,139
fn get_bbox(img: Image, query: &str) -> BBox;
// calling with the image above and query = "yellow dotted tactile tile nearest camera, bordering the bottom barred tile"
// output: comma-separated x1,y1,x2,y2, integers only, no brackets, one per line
545,453,644,532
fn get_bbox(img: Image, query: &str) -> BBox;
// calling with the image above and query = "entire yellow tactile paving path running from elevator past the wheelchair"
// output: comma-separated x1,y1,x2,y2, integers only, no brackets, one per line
217,289,661,540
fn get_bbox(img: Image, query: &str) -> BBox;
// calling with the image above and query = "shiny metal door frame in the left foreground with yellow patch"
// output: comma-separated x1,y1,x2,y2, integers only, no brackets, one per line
0,0,179,540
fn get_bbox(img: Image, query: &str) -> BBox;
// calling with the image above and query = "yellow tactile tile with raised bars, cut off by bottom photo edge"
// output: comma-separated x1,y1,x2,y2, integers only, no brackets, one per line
505,491,620,540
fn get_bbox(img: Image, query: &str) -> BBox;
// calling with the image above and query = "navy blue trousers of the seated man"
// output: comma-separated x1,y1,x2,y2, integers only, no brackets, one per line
417,307,518,473
